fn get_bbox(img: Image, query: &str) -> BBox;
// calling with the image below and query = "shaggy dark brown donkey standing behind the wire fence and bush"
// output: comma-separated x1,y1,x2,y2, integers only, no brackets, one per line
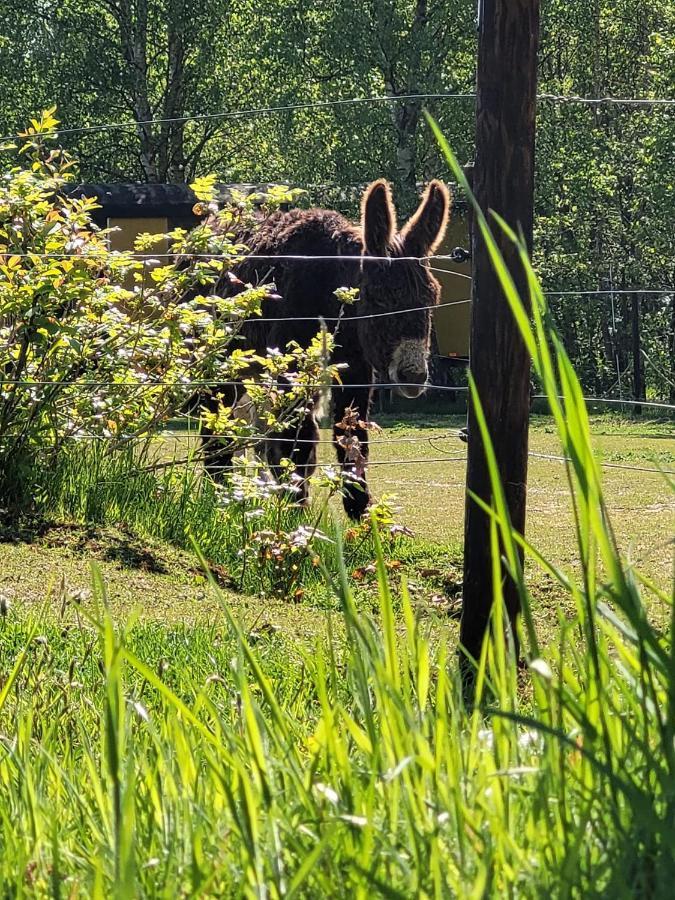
205,180,451,519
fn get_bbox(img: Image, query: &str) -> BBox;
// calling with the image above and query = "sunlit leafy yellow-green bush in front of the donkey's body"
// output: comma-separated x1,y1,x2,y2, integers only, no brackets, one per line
0,110,331,506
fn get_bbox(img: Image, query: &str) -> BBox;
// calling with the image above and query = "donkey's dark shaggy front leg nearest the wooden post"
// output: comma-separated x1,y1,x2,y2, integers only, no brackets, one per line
333,384,372,519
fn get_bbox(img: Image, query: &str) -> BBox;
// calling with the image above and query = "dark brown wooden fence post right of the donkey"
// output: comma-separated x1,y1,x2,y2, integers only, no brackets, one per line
460,0,539,687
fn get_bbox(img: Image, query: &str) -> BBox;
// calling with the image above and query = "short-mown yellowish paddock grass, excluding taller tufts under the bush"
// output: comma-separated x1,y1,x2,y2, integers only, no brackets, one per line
0,413,675,639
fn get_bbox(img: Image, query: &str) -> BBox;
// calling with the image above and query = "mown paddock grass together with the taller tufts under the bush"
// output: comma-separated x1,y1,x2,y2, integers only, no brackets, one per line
0,406,675,645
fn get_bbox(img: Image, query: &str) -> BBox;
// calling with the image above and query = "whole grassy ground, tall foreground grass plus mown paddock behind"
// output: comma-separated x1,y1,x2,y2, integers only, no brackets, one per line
0,417,675,900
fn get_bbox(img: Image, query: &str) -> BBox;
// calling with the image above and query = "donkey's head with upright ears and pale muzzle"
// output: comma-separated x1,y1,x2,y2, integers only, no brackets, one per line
358,180,450,398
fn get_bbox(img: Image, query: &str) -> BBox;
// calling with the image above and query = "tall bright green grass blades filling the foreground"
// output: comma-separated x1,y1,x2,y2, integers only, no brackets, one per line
0,492,675,898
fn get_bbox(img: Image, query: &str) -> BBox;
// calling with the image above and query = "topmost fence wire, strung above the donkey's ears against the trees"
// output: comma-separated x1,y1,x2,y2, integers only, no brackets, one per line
5,92,675,142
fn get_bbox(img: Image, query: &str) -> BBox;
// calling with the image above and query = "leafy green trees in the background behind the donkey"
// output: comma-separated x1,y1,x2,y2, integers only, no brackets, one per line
0,0,675,402
